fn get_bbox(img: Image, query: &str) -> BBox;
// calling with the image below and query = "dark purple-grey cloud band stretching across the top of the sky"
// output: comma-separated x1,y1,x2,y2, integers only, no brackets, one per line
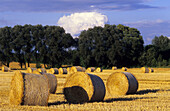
0,0,159,13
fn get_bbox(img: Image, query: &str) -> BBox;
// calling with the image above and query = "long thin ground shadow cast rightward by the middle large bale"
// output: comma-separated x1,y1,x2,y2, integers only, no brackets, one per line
104,97,157,103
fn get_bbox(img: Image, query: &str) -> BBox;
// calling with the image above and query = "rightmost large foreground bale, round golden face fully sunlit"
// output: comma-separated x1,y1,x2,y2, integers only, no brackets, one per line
106,72,138,96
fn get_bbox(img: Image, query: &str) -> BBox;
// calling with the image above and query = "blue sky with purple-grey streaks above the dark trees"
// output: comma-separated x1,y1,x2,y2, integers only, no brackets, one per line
0,0,170,44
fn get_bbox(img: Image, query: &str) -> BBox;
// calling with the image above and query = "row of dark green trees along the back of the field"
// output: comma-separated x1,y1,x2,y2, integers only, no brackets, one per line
0,24,170,68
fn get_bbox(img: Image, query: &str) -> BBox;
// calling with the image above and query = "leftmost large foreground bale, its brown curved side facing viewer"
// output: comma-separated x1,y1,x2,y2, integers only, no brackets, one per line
9,71,49,106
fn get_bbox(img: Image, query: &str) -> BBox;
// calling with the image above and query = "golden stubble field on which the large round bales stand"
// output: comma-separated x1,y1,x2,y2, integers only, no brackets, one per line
0,68,170,111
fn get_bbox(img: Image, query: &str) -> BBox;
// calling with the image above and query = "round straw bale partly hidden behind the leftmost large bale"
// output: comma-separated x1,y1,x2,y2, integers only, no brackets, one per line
43,73,57,94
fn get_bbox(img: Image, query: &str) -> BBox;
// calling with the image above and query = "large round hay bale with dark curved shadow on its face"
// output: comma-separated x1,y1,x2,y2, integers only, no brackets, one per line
63,72,105,103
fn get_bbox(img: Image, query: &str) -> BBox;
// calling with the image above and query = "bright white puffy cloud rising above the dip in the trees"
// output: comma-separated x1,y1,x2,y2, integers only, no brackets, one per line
57,12,108,36
